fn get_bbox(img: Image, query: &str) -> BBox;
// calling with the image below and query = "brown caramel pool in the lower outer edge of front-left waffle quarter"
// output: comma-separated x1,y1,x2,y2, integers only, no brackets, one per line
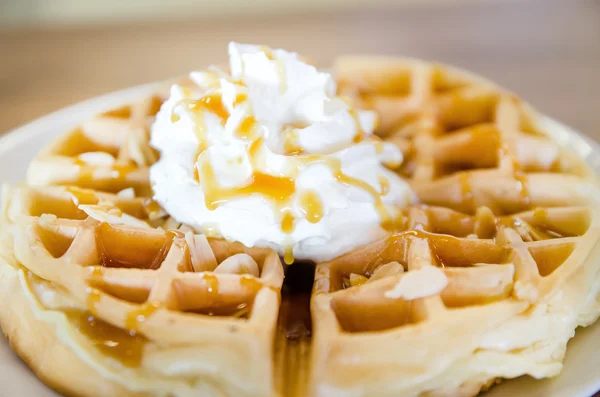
65,312,147,367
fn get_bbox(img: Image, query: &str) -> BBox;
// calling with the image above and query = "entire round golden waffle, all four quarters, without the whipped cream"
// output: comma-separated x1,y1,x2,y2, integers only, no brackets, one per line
0,57,600,396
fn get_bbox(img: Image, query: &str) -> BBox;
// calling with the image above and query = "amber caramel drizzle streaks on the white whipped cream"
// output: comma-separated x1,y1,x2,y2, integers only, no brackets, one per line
172,55,397,262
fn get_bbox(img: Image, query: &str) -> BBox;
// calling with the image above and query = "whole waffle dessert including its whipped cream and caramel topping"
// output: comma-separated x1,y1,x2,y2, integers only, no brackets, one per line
0,43,600,397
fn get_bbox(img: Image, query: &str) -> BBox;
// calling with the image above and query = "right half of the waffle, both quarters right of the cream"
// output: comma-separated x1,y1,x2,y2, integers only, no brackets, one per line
302,57,600,396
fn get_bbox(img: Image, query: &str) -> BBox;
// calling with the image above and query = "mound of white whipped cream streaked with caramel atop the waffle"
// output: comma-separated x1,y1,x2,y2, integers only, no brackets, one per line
150,43,414,263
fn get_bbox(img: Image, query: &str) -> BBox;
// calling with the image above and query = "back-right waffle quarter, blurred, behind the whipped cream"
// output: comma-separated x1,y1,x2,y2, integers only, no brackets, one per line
335,57,598,213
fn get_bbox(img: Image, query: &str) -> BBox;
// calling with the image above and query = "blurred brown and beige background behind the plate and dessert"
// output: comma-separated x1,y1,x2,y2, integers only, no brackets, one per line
0,0,600,140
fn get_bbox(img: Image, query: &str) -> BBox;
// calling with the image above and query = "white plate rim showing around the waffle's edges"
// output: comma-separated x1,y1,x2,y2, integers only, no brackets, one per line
0,84,600,397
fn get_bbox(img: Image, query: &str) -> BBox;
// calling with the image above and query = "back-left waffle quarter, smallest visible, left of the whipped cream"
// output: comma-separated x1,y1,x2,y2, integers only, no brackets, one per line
27,94,165,196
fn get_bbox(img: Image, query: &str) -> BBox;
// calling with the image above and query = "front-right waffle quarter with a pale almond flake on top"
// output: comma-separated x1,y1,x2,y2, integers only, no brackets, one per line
312,207,600,396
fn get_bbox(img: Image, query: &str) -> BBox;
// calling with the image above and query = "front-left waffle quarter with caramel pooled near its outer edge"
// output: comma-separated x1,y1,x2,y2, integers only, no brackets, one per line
0,183,283,396
